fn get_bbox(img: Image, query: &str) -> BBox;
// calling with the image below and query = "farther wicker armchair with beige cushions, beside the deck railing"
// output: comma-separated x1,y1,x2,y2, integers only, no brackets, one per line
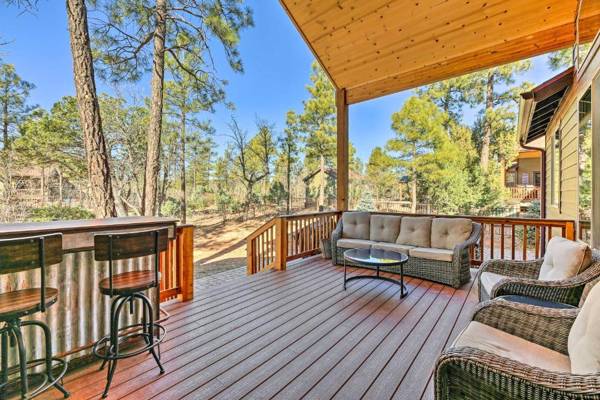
477,237,600,306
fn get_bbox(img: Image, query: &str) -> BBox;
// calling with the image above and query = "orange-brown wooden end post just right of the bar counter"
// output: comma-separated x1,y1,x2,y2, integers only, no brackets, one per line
176,225,194,301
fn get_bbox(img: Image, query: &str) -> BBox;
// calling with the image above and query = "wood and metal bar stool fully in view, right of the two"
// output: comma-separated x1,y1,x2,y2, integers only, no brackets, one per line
93,229,169,398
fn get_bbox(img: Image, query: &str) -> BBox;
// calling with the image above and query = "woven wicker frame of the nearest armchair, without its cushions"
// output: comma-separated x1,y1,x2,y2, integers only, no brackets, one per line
435,299,600,400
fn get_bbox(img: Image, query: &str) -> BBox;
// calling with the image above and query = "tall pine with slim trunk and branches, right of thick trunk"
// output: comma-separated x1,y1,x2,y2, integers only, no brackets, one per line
93,0,253,215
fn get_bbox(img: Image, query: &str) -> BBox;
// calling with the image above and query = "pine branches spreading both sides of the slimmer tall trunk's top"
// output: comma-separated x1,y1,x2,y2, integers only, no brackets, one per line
92,0,253,84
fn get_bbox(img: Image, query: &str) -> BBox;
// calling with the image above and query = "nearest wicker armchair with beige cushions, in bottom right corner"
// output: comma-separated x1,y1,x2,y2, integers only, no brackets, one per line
435,285,600,400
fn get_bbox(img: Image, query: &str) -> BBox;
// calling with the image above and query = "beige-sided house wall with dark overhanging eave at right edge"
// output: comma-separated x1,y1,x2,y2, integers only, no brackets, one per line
519,36,600,247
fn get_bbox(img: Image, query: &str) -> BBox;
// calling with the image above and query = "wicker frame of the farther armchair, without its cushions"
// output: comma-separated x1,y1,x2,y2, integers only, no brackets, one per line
477,250,600,306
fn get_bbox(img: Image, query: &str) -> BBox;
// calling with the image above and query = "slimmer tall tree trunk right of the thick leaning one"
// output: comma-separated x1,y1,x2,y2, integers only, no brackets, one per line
143,0,167,215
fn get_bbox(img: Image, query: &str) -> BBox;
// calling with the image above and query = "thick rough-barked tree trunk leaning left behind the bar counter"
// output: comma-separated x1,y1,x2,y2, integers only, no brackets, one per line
67,0,116,218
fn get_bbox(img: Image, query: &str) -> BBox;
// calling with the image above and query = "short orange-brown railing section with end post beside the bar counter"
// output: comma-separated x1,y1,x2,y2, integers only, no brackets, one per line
159,225,194,302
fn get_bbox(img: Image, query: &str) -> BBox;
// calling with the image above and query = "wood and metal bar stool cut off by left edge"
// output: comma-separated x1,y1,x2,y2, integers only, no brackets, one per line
0,234,69,399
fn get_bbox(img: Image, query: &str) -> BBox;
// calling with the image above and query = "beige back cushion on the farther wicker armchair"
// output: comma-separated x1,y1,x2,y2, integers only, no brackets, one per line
538,236,592,281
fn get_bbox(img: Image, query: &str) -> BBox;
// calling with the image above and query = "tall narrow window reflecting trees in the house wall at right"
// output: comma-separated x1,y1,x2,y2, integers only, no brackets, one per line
577,90,592,243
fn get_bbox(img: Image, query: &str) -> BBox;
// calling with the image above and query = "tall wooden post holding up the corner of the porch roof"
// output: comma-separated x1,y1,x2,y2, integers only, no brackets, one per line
335,89,349,211
